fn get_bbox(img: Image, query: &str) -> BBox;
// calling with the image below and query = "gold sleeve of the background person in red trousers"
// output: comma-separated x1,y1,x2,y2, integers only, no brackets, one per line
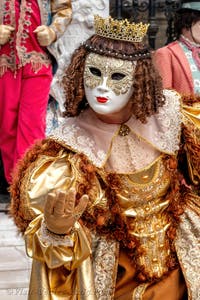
50,0,72,39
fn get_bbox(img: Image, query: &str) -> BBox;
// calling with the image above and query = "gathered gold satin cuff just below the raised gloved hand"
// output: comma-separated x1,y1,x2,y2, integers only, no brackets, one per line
25,215,91,270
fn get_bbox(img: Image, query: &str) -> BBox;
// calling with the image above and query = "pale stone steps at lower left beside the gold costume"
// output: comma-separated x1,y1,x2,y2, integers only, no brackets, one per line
0,213,32,300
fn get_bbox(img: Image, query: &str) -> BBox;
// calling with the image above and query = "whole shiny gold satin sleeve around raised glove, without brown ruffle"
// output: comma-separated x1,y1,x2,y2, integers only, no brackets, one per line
12,142,90,270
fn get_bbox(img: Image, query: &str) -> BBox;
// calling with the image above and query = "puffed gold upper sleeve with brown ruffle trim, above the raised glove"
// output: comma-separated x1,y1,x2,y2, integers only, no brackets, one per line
10,139,92,233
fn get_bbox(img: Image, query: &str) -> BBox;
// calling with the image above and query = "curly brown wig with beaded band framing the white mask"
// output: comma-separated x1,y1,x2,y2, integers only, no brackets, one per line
63,35,165,123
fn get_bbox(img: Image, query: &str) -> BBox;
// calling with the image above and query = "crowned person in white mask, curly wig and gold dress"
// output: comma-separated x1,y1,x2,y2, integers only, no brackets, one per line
11,16,200,300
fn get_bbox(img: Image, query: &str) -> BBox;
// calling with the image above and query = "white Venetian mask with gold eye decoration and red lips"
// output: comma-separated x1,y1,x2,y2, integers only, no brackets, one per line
84,53,136,115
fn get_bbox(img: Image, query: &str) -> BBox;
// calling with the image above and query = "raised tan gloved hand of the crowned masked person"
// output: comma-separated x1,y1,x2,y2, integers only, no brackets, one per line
44,190,89,234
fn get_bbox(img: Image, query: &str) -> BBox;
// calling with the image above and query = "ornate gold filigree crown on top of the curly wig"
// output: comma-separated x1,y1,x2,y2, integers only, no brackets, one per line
94,15,149,43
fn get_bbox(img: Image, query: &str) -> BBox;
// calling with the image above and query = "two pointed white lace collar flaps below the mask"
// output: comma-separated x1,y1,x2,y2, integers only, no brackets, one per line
51,90,181,167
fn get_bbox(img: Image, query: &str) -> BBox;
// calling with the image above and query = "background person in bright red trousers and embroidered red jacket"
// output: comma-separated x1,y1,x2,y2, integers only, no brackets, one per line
0,0,72,183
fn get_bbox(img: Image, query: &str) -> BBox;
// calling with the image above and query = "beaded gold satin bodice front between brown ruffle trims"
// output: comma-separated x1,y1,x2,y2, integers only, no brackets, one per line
114,159,170,278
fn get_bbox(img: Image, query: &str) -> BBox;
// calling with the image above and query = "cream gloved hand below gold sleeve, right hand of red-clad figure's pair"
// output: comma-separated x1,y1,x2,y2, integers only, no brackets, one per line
33,25,56,46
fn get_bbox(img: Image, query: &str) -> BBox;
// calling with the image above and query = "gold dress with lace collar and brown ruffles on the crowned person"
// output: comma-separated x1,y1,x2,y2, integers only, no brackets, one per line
11,91,200,300
